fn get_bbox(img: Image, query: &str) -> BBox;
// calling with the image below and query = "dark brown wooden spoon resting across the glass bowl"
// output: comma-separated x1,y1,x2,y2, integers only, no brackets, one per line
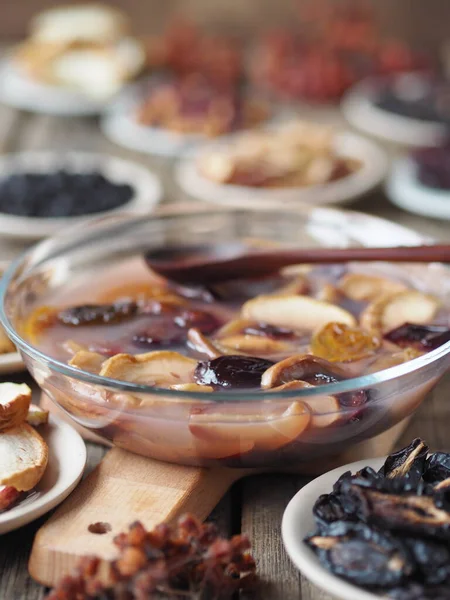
145,242,450,284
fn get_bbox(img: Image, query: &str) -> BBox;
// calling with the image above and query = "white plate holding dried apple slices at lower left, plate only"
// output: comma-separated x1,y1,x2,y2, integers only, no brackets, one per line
0,416,86,534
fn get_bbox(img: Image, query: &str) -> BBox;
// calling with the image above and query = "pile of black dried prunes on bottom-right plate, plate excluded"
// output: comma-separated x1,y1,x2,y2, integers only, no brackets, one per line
305,439,450,600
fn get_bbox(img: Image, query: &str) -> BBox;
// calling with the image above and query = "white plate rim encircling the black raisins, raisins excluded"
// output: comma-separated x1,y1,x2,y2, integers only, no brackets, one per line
0,151,162,240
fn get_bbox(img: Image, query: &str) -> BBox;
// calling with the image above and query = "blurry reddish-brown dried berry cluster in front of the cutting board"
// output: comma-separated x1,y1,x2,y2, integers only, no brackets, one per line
47,515,255,600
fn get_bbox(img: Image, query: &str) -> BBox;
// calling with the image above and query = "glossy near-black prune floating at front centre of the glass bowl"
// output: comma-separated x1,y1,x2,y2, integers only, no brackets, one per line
194,355,274,388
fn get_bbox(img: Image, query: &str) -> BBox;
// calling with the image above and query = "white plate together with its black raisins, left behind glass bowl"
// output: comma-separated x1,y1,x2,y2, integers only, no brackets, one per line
0,151,162,240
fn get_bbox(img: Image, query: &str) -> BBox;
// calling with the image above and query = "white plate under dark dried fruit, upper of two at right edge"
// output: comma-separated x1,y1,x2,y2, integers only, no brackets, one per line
341,78,446,146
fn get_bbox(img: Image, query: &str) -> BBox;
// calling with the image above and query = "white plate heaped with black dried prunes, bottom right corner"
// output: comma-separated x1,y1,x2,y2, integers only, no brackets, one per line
282,438,450,600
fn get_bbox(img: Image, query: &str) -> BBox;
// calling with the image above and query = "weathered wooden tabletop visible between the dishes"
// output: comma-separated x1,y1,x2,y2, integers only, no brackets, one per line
0,96,450,600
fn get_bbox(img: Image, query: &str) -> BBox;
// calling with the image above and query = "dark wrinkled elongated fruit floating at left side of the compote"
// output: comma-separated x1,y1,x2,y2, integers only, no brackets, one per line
57,302,138,327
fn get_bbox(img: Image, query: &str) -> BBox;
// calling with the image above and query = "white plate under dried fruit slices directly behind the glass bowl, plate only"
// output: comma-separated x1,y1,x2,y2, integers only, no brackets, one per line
175,132,387,208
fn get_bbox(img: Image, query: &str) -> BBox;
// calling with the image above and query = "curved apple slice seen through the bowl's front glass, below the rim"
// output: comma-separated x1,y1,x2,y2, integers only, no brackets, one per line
189,402,310,450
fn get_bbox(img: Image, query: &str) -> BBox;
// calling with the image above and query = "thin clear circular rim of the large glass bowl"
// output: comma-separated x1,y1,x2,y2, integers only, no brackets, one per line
0,206,450,412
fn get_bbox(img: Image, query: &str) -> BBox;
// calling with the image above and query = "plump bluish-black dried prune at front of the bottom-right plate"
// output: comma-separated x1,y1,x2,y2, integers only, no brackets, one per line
305,521,414,588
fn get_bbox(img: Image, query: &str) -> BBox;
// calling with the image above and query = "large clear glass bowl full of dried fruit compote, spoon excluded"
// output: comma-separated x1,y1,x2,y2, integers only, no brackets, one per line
0,205,450,469
